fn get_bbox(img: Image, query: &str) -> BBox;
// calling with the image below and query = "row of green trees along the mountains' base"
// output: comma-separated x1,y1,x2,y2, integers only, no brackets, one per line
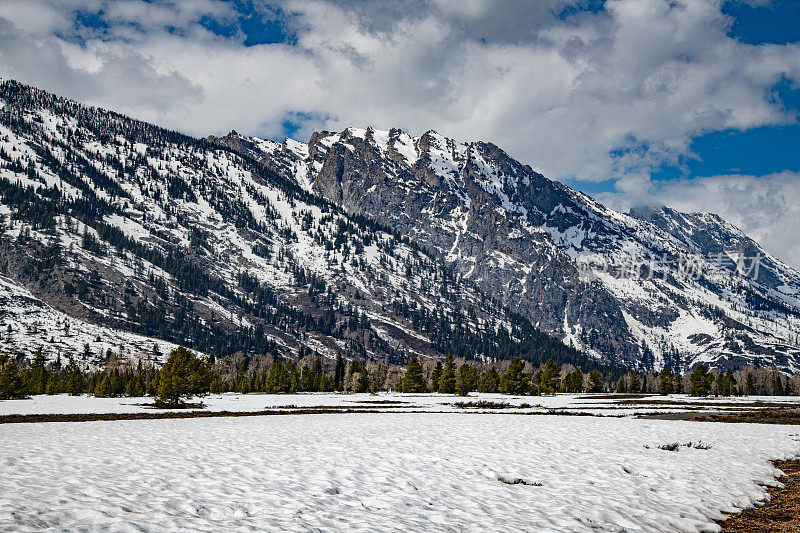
6,347,800,405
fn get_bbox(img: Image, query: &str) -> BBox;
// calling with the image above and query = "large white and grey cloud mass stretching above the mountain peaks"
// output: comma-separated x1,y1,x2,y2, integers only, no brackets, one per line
0,0,800,180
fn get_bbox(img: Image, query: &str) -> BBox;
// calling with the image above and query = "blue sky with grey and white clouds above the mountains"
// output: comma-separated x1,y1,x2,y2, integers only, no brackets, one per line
0,0,800,266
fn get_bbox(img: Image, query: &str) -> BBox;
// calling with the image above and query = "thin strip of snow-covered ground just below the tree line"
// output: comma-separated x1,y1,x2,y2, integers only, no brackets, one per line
0,393,800,416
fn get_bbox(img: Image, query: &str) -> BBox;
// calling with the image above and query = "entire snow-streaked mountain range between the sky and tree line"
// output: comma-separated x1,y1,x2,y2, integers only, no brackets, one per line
0,80,800,372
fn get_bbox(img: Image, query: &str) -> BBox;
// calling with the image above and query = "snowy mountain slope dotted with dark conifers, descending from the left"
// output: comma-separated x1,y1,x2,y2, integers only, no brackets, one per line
0,81,586,366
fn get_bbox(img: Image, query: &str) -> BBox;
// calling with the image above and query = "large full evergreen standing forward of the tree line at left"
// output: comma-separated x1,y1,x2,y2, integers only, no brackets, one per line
158,346,211,406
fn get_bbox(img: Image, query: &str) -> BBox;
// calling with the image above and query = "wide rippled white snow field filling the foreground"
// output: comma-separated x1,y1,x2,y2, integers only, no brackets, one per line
0,413,800,532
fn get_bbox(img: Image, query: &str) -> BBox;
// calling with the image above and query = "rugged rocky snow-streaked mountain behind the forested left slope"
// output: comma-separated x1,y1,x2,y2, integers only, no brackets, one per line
209,128,800,371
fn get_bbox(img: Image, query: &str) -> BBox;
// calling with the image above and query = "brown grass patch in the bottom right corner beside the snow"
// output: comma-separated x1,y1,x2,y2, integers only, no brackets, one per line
719,460,800,533
